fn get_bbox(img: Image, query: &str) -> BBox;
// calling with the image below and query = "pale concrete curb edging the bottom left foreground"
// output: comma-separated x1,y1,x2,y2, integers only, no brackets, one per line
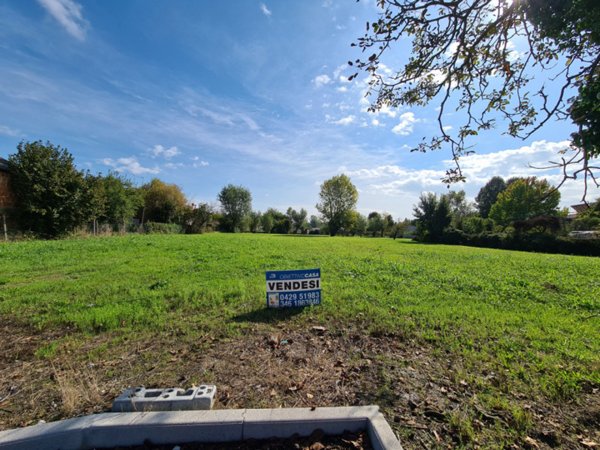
0,406,402,450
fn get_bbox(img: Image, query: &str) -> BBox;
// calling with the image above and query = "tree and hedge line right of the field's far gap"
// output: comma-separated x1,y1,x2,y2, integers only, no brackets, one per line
414,176,600,255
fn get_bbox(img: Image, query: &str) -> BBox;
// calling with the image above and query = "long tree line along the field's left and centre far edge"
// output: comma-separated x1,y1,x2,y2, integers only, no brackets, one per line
8,141,408,238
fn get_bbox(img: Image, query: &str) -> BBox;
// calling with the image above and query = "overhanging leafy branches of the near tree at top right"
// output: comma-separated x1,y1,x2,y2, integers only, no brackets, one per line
349,0,600,198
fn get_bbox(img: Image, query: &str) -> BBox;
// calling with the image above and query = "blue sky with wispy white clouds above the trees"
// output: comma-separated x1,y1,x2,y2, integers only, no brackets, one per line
0,0,600,219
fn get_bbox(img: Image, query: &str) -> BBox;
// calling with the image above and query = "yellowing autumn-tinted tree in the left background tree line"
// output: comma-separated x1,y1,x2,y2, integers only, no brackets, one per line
141,178,187,223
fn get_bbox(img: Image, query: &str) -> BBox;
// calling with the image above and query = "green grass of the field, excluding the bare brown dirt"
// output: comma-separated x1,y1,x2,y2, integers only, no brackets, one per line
0,234,600,448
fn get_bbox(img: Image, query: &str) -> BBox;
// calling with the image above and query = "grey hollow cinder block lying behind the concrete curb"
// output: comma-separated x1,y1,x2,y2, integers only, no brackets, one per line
112,384,217,412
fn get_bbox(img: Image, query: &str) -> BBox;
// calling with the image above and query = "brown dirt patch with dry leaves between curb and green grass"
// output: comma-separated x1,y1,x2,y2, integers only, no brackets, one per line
0,323,600,449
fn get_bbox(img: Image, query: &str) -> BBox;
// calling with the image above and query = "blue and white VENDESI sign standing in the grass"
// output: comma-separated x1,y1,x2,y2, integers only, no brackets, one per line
267,269,321,308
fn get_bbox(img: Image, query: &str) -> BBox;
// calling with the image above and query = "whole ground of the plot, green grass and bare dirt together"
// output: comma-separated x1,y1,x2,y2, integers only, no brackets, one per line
0,233,600,448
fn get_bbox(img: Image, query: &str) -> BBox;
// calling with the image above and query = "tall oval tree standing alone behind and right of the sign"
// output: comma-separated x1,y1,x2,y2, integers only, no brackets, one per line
316,174,358,236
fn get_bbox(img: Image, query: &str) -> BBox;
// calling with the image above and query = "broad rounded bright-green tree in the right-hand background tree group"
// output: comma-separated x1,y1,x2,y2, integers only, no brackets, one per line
490,177,560,225
